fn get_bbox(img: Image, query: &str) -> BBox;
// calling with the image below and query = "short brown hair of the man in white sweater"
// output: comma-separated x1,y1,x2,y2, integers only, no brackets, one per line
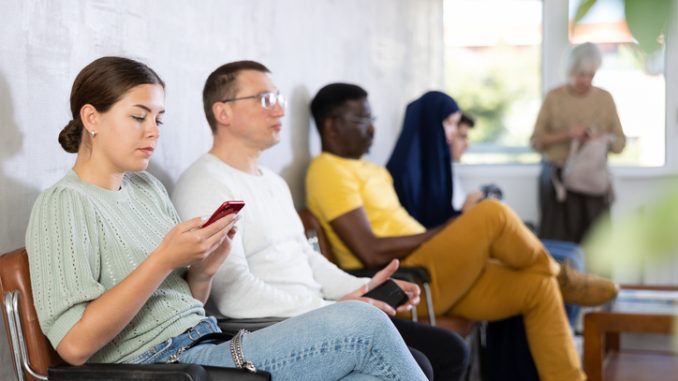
202,61,271,134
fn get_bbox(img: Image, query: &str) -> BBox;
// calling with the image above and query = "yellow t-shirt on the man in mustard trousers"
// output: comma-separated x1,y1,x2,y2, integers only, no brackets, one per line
306,152,426,269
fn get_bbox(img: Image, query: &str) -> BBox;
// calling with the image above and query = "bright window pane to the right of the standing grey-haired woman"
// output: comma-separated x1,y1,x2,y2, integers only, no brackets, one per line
570,0,666,166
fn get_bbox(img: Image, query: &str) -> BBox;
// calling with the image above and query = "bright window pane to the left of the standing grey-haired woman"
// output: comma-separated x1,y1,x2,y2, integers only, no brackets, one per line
444,0,542,164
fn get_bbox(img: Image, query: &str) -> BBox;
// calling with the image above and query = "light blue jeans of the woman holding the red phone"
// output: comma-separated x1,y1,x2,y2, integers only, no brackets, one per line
125,301,426,380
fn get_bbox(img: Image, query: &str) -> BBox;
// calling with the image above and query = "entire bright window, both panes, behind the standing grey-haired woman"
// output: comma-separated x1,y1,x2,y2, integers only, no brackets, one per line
444,0,666,167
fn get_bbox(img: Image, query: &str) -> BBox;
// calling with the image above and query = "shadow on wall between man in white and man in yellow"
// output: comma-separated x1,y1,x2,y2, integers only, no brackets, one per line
280,85,311,209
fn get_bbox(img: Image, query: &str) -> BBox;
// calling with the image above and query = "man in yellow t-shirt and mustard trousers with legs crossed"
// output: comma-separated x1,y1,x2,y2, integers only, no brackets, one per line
306,83,616,381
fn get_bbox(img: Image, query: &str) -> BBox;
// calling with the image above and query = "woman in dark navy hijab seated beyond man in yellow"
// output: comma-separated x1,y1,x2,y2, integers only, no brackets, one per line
386,91,538,381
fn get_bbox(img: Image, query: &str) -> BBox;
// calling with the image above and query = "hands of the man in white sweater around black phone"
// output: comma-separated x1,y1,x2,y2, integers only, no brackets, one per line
339,259,421,316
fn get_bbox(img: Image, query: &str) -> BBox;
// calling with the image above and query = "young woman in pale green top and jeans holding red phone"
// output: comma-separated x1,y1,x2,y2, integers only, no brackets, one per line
26,57,424,380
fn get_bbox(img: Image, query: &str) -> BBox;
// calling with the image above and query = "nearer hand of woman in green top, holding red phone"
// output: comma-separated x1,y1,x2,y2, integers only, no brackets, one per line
152,214,235,270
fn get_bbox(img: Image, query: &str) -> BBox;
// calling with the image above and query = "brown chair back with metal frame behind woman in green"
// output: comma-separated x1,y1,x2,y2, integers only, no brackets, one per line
0,248,63,381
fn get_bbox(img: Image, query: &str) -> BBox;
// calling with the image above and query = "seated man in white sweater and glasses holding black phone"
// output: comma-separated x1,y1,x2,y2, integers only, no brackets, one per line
172,61,468,380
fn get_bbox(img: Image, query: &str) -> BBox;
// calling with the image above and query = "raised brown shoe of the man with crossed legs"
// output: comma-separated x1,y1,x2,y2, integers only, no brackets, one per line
557,262,619,306
